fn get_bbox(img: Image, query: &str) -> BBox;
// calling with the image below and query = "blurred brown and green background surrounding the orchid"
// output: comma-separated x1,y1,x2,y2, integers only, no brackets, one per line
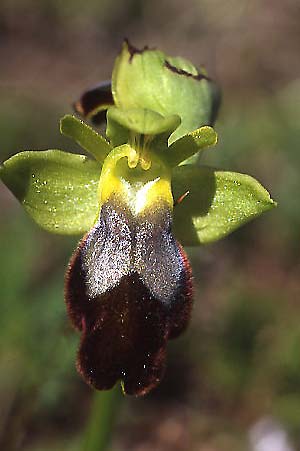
0,0,300,451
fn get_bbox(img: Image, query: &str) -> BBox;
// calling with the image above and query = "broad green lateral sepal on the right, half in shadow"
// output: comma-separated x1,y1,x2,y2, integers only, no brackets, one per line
172,165,276,246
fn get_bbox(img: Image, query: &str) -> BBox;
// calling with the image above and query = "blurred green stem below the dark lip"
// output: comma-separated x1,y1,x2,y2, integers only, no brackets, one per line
81,386,122,451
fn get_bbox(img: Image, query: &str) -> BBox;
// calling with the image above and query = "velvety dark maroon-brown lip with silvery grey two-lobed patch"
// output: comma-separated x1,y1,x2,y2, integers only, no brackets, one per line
66,198,192,396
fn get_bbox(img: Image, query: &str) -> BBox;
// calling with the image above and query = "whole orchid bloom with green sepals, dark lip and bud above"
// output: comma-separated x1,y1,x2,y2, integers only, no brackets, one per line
0,41,275,396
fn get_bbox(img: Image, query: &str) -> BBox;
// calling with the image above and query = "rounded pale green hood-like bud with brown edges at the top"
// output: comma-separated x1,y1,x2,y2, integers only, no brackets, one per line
112,42,217,144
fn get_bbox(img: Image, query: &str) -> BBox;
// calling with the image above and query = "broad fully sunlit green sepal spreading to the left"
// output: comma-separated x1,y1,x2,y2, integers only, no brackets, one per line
0,150,101,235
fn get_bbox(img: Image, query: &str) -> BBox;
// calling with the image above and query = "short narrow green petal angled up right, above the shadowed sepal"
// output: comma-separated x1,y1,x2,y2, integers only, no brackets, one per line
165,126,218,166
